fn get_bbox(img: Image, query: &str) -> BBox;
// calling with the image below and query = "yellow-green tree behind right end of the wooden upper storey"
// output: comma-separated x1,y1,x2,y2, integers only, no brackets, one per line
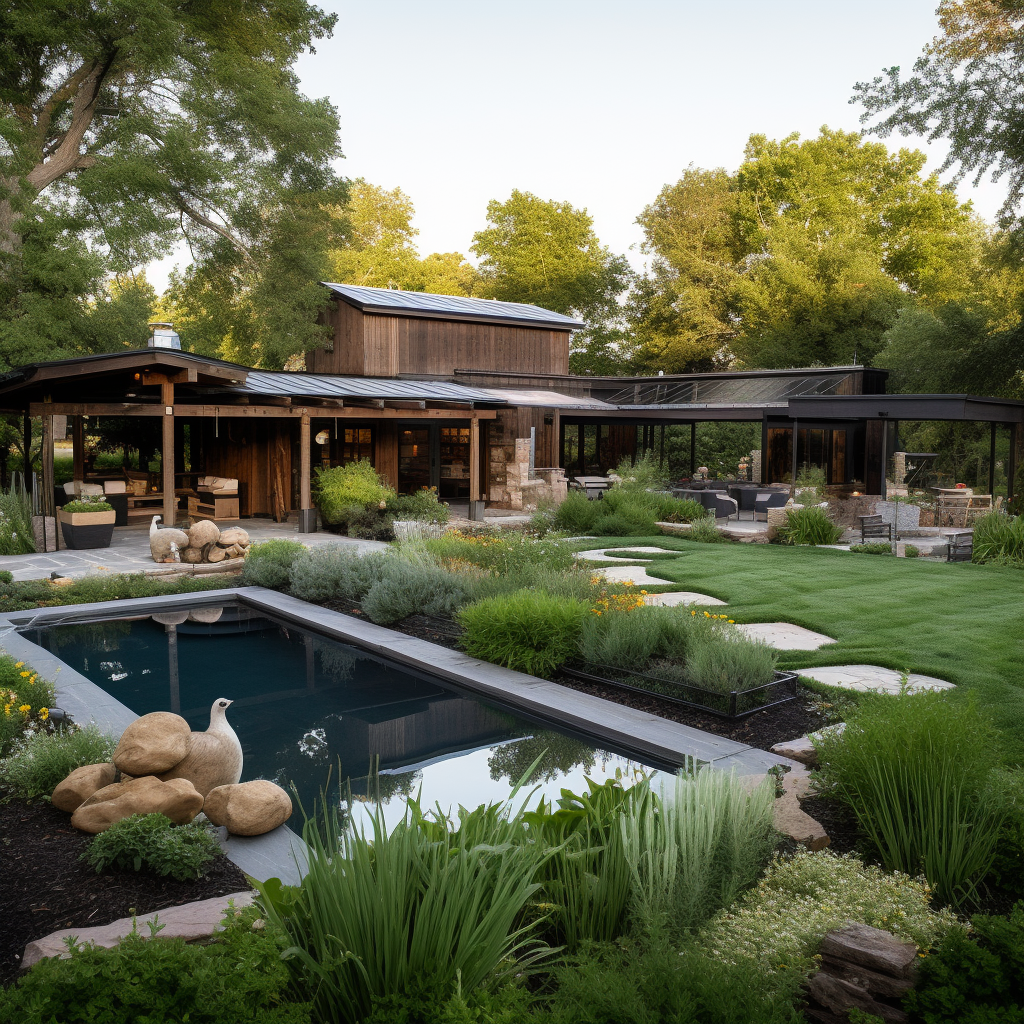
472,189,630,373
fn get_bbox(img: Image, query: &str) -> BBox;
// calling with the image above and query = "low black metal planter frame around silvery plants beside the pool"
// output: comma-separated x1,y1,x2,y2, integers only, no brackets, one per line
561,665,797,718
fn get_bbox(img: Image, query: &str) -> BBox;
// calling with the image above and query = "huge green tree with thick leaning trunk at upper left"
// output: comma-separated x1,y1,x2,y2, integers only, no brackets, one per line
0,0,341,365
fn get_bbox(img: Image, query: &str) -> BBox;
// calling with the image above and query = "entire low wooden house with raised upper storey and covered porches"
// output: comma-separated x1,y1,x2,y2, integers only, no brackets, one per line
0,284,1024,528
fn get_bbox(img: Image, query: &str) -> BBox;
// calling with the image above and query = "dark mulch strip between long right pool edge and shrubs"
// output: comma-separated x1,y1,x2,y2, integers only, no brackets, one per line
326,601,828,750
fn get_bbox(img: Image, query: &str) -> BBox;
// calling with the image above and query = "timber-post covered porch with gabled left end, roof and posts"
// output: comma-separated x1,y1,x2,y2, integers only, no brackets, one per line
0,347,503,528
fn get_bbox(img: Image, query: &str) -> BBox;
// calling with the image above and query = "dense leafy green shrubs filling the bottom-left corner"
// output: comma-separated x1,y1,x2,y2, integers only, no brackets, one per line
0,910,310,1024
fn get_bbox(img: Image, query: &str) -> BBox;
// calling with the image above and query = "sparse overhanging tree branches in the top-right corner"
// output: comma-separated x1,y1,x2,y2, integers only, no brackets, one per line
854,0,1024,229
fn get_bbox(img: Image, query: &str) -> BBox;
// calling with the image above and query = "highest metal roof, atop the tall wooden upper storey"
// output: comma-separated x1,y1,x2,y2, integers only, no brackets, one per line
321,281,584,331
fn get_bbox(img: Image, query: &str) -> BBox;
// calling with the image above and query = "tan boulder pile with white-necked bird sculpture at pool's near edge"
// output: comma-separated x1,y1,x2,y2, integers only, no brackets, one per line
50,697,292,836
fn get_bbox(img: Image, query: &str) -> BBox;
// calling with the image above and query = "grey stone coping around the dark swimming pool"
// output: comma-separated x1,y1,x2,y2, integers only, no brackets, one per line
0,587,799,884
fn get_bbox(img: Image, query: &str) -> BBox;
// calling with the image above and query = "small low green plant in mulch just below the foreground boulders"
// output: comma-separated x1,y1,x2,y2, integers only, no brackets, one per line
81,814,220,882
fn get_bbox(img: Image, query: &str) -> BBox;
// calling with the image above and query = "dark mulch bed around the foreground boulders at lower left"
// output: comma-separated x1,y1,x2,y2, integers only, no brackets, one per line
0,802,250,984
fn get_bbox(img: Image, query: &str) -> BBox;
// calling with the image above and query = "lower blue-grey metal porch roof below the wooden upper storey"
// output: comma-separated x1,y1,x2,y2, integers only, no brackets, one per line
230,370,505,404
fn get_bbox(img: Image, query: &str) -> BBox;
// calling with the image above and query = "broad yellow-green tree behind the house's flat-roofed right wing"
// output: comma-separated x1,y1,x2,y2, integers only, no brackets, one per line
634,128,984,371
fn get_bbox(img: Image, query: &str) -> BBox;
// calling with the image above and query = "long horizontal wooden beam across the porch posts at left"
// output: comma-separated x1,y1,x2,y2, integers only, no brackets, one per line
29,399,498,421
